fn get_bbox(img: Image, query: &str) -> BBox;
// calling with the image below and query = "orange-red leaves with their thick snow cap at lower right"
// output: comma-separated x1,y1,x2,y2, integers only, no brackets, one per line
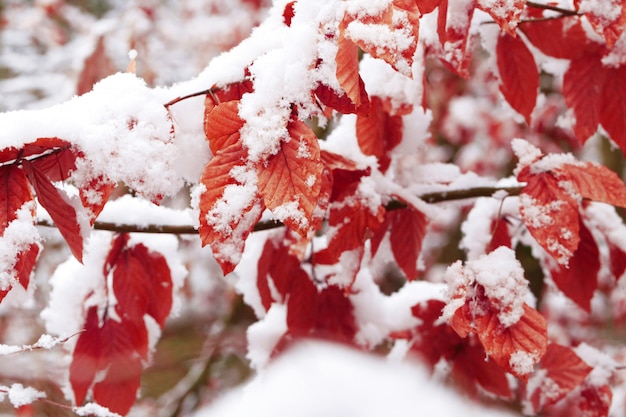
442,247,547,379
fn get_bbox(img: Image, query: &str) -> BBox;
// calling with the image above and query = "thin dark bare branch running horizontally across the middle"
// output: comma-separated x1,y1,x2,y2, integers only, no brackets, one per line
37,185,524,235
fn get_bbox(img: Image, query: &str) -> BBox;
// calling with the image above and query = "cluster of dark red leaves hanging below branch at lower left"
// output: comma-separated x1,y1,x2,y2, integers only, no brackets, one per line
70,234,172,415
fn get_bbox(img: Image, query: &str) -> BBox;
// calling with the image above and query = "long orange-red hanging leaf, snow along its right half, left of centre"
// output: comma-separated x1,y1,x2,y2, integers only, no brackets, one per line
199,142,263,274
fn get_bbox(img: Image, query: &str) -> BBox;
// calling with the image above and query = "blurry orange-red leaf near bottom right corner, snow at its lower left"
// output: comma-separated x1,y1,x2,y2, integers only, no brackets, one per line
527,343,593,413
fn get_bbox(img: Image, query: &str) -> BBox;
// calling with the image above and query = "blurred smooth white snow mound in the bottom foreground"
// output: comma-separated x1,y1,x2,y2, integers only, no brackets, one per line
193,341,513,417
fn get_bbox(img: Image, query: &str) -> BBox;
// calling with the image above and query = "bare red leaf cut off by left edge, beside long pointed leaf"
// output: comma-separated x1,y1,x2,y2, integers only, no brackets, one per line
0,165,33,232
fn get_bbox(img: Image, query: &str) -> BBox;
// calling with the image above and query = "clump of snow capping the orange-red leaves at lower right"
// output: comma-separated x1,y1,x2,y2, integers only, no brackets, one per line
442,246,530,327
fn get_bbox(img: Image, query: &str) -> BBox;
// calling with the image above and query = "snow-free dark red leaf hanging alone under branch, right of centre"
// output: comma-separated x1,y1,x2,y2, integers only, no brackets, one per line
386,206,428,280
